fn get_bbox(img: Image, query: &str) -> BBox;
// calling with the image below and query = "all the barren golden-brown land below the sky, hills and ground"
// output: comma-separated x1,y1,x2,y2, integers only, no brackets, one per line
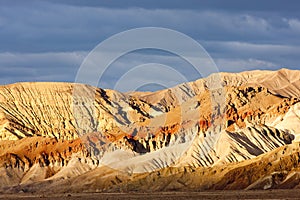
0,69,300,199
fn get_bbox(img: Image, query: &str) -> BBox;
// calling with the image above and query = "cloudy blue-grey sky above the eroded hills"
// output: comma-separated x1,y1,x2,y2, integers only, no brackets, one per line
0,0,300,90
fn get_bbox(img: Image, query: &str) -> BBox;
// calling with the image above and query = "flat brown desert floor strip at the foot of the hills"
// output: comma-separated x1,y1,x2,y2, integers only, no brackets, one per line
0,189,300,200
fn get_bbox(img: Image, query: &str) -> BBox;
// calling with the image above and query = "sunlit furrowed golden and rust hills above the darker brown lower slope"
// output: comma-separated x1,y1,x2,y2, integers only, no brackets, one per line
0,69,300,192
